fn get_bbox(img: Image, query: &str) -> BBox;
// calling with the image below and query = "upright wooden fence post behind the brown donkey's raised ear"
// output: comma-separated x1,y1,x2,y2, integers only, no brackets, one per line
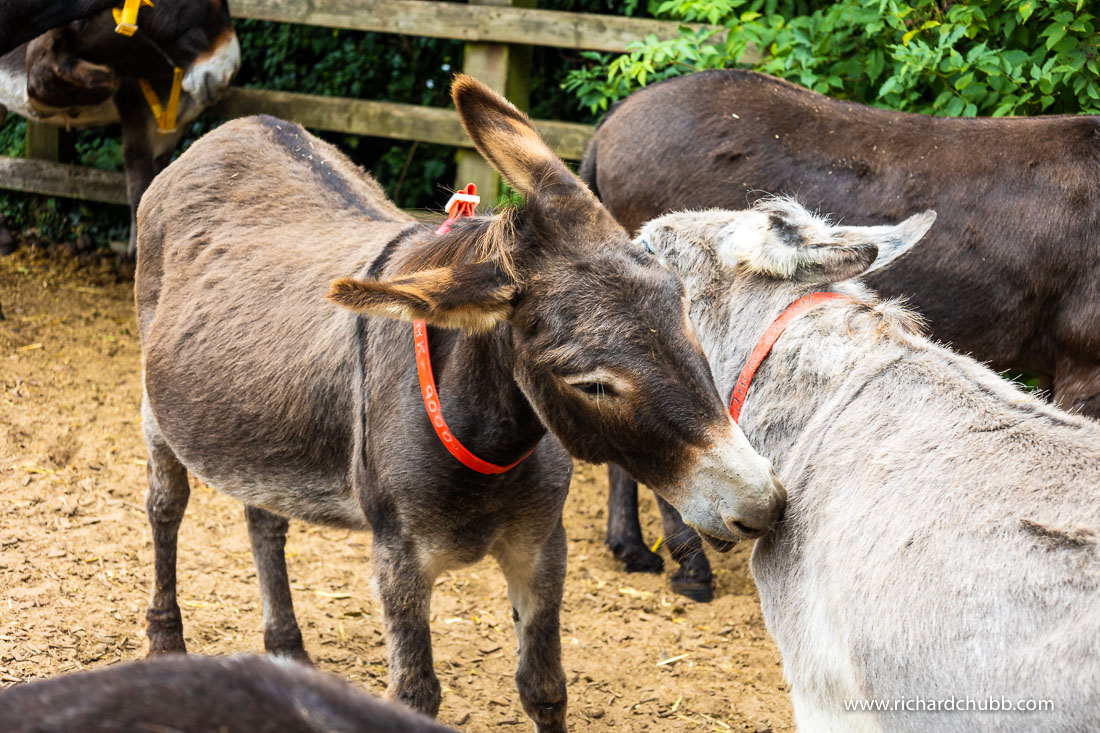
454,0,536,207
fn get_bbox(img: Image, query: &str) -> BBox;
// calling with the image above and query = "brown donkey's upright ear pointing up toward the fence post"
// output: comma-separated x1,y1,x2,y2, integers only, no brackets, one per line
451,74,587,196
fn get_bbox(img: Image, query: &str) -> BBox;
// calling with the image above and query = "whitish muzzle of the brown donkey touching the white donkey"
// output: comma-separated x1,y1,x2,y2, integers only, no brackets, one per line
670,429,787,553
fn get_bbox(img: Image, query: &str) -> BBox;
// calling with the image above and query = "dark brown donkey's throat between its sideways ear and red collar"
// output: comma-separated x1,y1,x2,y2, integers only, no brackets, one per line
418,324,547,466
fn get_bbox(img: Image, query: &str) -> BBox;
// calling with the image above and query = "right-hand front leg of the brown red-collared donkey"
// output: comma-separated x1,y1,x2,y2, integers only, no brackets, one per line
496,522,567,733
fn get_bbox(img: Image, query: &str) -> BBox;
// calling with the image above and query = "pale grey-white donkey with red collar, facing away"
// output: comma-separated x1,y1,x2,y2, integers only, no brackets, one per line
639,195,1100,733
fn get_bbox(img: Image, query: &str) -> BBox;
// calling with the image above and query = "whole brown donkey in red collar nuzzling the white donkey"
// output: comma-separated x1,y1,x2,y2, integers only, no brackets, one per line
135,77,784,731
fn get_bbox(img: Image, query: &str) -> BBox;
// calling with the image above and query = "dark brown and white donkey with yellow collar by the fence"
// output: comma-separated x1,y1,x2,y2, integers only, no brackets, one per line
0,0,241,256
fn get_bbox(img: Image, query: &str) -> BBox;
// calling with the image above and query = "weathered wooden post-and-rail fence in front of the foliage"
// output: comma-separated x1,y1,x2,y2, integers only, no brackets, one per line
0,0,755,204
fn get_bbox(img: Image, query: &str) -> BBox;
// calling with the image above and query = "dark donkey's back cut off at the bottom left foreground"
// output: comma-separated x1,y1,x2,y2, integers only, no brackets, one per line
0,655,451,733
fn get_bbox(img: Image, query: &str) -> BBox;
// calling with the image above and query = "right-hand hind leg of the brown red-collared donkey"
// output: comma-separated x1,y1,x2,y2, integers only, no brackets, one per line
244,506,310,665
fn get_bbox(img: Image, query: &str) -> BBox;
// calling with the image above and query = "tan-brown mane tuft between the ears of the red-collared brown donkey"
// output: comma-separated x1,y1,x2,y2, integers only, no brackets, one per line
393,208,519,283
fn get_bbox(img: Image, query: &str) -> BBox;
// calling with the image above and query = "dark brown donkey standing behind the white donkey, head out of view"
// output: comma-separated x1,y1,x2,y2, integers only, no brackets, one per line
582,65,1100,598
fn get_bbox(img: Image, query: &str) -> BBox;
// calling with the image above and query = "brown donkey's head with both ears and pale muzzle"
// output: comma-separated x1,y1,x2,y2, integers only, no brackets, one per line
330,76,785,544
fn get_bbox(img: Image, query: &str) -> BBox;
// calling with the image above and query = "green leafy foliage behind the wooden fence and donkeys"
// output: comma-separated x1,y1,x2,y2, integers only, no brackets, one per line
0,0,1100,245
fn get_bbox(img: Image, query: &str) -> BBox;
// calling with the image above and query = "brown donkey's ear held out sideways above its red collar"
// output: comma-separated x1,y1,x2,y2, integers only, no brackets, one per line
328,261,516,331
